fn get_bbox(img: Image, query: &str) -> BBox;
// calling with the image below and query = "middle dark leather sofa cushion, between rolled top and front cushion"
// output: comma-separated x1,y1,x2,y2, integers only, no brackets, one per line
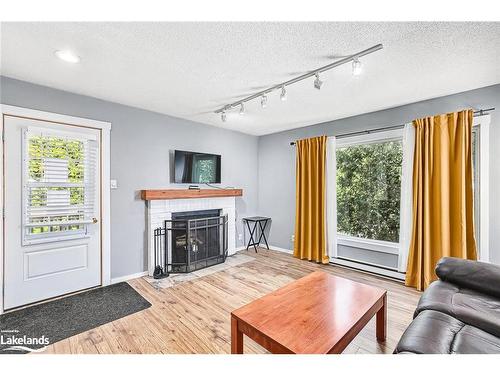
415,280,500,336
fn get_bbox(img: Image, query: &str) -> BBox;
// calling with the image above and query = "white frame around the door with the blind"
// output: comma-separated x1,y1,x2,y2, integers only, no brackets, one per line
0,104,111,314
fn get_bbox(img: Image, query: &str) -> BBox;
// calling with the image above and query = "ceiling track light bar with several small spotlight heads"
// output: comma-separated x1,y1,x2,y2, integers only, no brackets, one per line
214,44,384,122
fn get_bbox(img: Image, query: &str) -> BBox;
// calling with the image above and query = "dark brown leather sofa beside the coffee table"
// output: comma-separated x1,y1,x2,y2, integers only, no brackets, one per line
394,258,500,354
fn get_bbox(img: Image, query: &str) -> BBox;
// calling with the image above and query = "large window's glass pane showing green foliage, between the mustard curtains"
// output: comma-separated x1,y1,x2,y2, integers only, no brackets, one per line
336,138,403,243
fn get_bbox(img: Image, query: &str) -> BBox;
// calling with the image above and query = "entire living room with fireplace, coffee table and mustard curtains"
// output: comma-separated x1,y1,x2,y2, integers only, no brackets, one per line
0,0,500,374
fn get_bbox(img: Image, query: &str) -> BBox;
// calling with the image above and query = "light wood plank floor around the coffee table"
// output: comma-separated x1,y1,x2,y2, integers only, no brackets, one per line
45,249,420,354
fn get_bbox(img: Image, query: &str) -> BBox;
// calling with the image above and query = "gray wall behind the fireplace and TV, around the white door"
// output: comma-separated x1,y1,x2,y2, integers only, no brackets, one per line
0,77,258,277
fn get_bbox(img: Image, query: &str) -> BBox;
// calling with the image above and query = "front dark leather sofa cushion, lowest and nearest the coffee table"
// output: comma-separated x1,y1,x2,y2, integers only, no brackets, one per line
394,310,500,354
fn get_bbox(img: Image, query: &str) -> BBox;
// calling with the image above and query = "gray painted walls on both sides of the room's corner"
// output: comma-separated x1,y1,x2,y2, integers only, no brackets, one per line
0,77,500,277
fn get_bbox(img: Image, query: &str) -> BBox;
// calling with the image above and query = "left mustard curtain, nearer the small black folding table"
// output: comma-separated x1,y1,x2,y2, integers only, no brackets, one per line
293,136,329,263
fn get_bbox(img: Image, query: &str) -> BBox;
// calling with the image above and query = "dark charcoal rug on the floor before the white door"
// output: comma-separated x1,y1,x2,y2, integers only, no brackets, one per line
0,282,151,353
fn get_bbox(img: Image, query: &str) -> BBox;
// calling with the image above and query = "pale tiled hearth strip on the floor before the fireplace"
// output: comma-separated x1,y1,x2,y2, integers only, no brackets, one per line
144,253,255,290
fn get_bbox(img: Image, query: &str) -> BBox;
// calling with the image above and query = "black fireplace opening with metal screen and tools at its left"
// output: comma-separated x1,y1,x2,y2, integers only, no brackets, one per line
154,209,228,278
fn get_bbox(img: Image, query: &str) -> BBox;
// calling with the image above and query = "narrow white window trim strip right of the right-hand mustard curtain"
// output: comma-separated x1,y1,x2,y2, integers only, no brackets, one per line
472,115,491,262
